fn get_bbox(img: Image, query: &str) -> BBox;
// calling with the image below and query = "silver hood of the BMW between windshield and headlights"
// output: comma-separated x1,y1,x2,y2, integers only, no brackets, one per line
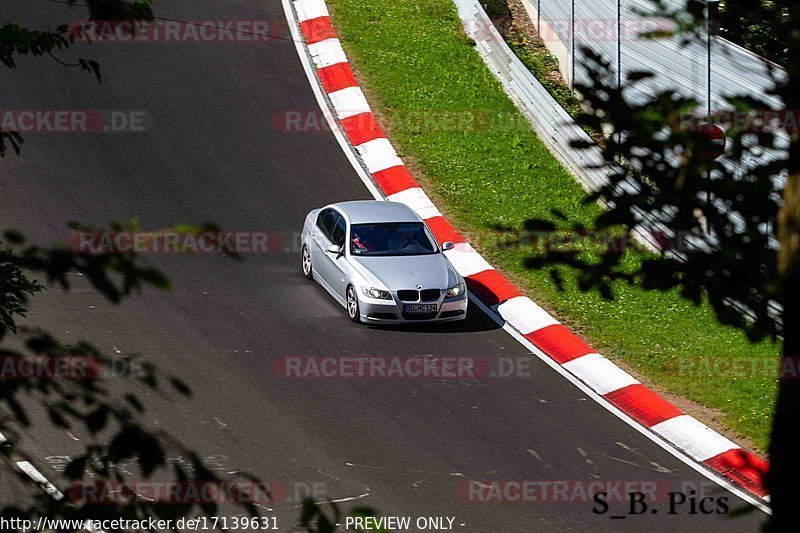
352,253,461,290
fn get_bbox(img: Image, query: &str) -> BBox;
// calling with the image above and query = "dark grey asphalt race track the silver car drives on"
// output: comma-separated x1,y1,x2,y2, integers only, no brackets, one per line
0,0,766,533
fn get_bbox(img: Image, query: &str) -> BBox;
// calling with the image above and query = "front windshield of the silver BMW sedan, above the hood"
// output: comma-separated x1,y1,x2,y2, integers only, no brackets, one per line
350,222,439,256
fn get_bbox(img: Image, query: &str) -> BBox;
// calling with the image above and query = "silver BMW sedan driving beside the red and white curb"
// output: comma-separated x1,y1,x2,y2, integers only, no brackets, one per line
300,200,467,324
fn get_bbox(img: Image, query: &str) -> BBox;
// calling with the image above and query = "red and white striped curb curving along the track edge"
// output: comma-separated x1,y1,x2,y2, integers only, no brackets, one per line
284,0,768,501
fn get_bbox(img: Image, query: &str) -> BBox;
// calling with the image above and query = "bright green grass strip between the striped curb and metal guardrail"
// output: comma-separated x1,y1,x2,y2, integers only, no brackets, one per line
329,0,780,452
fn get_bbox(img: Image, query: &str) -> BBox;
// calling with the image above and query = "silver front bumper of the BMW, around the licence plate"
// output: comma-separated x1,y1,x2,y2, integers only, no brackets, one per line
359,292,469,325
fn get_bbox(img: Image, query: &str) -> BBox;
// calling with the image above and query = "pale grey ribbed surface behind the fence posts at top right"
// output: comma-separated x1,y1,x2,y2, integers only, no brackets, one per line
522,0,785,112
